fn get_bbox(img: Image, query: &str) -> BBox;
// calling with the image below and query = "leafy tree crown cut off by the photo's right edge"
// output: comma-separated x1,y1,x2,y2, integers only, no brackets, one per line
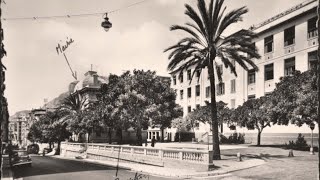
270,70,318,126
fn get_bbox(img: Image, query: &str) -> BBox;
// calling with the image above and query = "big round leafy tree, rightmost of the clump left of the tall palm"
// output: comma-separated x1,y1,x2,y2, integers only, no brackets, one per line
113,70,182,145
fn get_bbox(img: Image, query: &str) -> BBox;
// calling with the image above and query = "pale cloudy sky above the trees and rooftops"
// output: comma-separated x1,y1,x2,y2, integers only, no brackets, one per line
2,0,316,132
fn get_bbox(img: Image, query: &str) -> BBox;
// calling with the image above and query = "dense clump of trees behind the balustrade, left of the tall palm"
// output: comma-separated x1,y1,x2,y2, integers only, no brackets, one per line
55,70,182,145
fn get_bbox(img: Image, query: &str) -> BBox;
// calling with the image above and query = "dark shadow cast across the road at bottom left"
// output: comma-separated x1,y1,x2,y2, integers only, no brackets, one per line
13,156,116,178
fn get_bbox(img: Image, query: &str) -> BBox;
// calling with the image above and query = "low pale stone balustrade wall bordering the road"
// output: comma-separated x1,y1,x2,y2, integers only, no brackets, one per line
61,143,212,170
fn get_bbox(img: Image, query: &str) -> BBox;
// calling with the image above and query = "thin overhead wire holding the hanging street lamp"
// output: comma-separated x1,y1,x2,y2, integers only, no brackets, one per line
2,0,149,21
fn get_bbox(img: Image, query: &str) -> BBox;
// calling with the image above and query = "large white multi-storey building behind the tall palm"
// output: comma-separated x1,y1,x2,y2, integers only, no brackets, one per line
171,0,318,139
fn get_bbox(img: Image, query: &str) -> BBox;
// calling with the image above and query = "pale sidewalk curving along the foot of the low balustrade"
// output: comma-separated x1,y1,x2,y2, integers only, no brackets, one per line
53,156,265,178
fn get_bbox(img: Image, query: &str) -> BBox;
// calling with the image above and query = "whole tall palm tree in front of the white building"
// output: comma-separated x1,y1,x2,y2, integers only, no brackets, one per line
165,0,260,159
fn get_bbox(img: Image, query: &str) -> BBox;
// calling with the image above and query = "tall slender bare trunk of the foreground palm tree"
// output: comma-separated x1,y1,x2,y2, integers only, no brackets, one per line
208,53,221,160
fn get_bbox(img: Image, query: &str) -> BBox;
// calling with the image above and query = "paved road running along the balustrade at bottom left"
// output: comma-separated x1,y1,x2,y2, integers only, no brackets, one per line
14,156,170,180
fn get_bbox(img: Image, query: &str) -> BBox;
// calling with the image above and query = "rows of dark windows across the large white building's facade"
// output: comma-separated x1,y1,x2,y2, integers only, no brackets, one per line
173,17,318,100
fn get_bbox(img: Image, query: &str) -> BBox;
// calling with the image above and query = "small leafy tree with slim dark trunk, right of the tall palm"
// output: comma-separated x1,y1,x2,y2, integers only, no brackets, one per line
232,97,273,146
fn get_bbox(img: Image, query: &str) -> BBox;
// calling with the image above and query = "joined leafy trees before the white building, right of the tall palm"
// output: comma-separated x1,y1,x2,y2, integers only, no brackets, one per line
233,69,318,145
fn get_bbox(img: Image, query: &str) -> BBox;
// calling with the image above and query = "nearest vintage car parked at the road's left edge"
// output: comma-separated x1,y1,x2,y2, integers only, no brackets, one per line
11,150,32,167
